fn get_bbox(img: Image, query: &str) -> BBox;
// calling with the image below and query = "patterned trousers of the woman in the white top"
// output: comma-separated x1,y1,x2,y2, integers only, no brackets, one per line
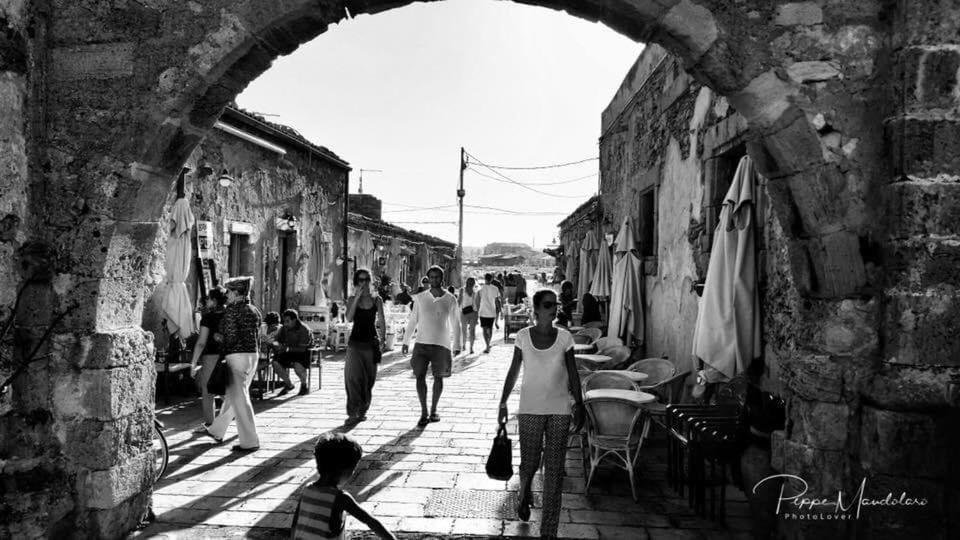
517,414,570,537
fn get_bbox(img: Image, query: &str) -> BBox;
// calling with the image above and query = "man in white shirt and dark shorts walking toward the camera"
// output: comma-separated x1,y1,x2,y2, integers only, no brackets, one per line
401,266,460,427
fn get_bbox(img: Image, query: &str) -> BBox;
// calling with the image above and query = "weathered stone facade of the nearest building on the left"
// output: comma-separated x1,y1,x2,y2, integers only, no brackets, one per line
143,107,350,347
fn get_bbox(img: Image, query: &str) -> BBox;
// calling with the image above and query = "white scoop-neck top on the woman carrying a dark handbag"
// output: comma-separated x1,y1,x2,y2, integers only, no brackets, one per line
514,326,573,414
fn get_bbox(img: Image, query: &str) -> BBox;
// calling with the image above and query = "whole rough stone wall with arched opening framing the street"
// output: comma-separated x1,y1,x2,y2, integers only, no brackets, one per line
0,0,960,538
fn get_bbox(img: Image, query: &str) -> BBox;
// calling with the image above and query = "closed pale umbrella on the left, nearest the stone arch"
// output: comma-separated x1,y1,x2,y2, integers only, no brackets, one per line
161,199,196,339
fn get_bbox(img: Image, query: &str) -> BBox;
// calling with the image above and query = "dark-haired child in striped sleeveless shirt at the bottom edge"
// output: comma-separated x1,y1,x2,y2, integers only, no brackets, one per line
290,433,396,540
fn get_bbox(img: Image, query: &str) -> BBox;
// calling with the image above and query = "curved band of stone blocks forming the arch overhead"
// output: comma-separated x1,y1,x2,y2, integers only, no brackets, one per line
116,0,866,304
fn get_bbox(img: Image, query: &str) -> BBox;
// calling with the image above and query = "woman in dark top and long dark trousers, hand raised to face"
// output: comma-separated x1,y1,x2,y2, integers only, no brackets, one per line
343,268,387,424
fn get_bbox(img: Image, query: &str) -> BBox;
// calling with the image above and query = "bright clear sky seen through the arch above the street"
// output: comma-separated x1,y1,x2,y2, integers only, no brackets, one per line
237,0,643,248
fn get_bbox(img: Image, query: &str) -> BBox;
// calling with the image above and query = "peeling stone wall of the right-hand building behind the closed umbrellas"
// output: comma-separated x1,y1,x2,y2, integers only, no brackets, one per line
599,45,745,370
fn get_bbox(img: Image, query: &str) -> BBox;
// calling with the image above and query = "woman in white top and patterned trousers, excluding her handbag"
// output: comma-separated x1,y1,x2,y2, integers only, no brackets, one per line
497,289,584,538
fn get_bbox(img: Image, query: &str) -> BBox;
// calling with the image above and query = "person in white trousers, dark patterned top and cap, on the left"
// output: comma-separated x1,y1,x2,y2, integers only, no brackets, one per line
207,277,262,452
